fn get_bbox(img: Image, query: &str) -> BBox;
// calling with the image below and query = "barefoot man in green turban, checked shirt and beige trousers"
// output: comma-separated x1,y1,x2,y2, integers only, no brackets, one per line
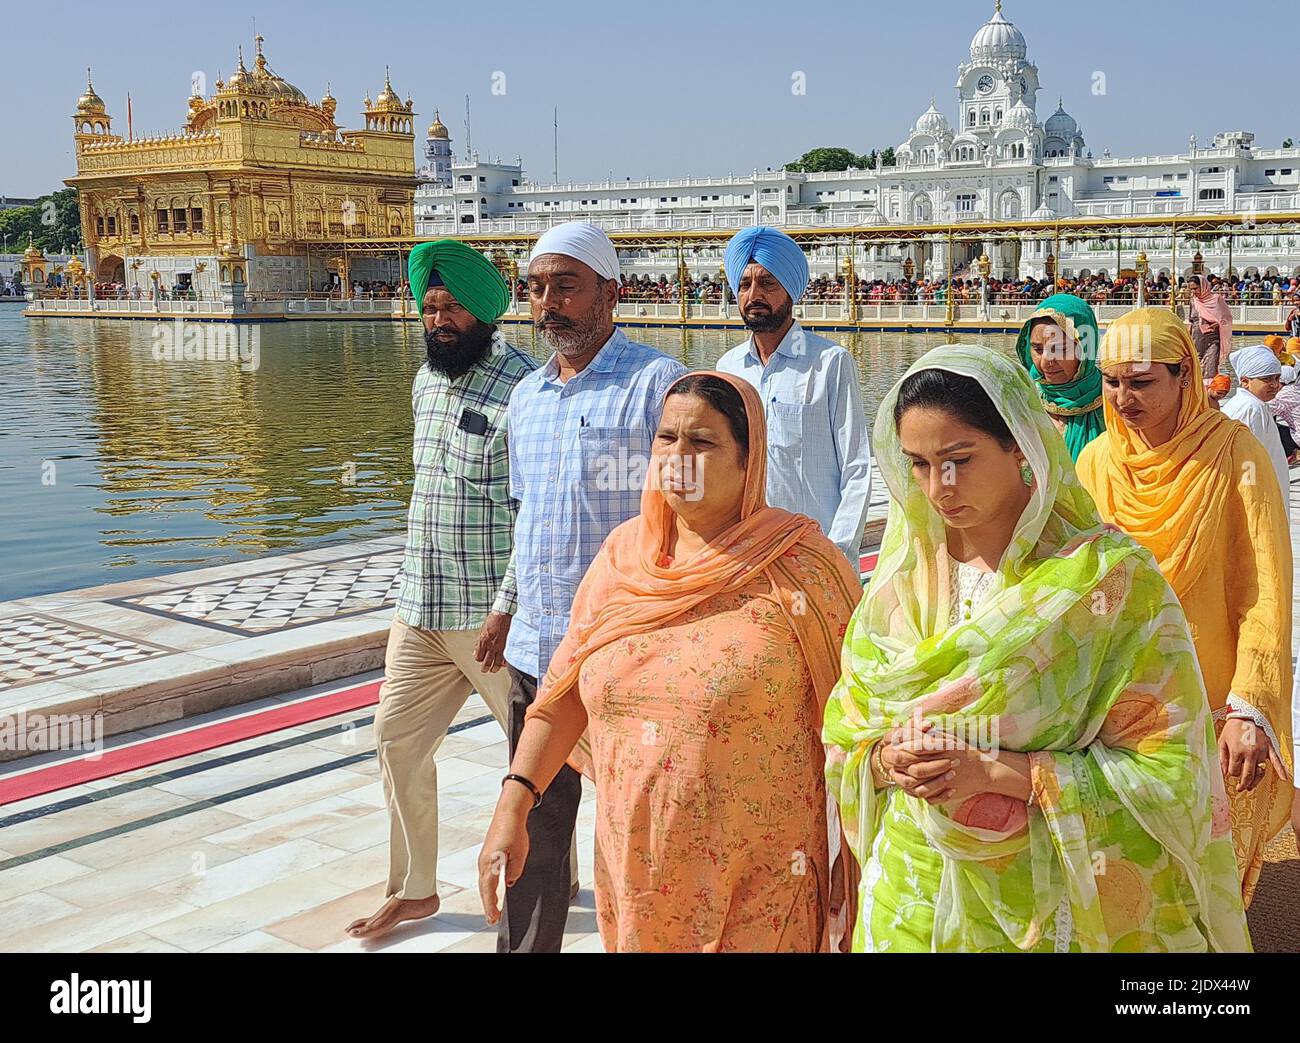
347,239,537,938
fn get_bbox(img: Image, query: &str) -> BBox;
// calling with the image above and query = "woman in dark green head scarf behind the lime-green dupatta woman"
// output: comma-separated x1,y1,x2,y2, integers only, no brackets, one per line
1015,294,1106,460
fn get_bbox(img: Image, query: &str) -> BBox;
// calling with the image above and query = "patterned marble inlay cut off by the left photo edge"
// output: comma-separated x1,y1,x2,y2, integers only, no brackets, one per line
0,613,174,691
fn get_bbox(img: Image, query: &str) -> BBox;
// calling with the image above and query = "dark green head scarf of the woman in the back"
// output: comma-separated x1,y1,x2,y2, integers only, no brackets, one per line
1015,294,1106,460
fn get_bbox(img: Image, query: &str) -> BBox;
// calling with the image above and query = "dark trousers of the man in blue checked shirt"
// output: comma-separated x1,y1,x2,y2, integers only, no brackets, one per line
497,663,582,952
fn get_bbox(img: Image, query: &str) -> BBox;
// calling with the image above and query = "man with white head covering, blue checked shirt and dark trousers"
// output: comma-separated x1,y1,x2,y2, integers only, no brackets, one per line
477,221,686,952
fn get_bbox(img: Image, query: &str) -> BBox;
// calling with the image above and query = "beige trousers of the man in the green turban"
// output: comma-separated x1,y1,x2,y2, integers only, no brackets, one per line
374,619,577,899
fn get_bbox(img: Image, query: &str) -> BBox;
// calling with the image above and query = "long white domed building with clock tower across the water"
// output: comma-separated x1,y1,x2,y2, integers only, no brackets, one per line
415,0,1300,278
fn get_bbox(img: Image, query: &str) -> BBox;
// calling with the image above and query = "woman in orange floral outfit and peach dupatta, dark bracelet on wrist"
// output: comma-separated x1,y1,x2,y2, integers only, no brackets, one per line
478,373,862,952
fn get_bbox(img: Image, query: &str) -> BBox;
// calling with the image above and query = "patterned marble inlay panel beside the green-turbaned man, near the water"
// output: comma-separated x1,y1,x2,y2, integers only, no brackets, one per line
113,549,403,636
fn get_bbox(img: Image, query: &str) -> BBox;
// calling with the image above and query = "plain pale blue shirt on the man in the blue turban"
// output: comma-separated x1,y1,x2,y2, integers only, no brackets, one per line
718,323,871,568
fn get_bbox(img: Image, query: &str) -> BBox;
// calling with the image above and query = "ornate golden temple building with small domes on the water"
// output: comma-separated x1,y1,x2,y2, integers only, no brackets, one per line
65,36,416,297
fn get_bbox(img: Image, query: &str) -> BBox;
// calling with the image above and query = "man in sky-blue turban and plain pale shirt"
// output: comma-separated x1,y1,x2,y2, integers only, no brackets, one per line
718,226,871,568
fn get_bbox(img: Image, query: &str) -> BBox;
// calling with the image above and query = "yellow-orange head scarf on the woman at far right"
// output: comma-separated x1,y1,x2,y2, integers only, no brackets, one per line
1091,308,1253,594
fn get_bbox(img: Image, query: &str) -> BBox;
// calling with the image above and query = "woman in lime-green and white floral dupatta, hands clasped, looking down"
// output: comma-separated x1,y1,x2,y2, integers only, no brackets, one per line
823,345,1249,952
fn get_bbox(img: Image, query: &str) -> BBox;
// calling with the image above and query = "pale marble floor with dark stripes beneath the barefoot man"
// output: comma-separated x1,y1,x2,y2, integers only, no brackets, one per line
0,676,601,952
